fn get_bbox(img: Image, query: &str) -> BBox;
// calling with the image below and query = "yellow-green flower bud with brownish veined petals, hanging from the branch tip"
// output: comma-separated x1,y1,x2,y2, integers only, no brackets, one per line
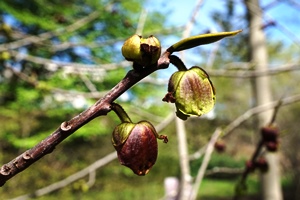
163,66,216,120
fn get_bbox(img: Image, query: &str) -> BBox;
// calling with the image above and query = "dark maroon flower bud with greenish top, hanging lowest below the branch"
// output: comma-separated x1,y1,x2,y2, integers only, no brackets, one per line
112,121,168,176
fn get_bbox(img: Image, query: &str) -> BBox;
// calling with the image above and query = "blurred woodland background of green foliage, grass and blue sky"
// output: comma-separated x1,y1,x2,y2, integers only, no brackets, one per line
0,0,300,199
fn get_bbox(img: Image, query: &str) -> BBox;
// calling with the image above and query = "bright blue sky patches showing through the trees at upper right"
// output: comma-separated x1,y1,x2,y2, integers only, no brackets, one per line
141,0,300,81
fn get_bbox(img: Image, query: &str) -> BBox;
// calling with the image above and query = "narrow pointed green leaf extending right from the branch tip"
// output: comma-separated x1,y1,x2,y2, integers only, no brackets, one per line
167,30,242,53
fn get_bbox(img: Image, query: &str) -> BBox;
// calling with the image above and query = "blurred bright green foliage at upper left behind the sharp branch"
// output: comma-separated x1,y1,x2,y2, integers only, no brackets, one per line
0,0,170,148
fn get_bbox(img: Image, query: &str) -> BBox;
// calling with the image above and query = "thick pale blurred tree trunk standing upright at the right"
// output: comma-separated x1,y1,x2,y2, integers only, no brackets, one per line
245,0,282,200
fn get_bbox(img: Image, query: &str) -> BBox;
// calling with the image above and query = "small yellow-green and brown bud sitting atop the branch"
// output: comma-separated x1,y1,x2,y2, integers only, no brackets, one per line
122,34,161,68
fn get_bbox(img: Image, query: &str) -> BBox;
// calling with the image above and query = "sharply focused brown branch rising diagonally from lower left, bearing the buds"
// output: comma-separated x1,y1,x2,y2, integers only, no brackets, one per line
0,52,170,186
